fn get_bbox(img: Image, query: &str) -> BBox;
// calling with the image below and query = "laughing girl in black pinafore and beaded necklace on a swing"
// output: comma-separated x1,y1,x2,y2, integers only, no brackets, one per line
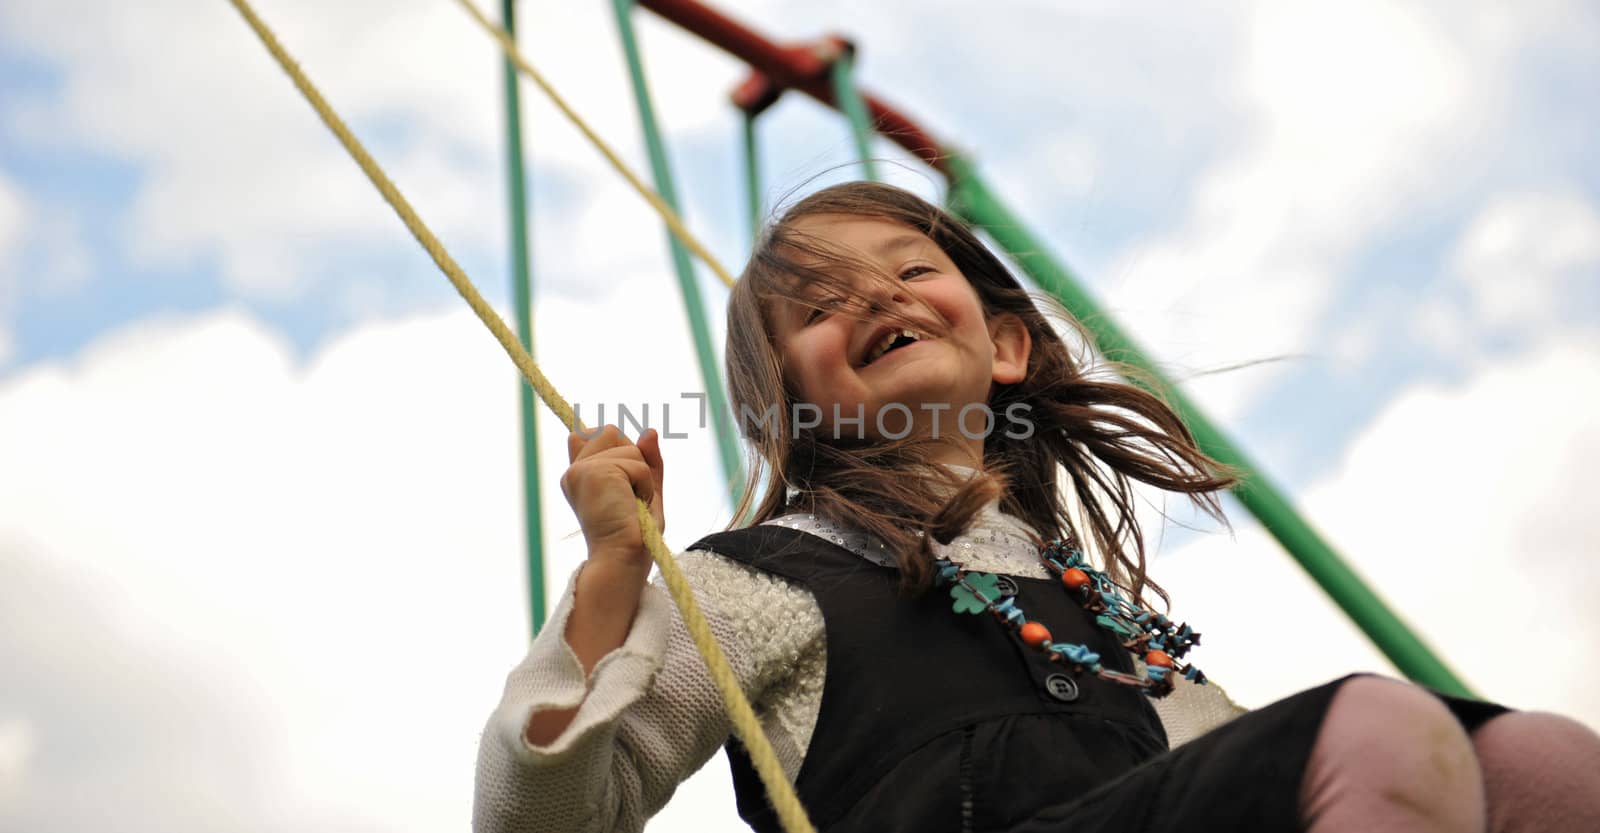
474,182,1600,833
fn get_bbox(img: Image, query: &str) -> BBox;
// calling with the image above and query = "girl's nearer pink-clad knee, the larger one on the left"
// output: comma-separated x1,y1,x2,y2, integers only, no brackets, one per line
1299,676,1486,833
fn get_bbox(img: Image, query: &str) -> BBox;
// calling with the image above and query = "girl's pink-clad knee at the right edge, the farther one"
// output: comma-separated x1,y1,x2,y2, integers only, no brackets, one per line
1472,711,1600,833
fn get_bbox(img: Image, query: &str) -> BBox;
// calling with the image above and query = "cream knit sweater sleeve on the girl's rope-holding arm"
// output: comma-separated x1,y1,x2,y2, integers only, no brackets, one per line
472,552,822,833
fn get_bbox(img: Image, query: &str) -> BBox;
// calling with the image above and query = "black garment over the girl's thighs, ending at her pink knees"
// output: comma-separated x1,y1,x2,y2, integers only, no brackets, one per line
1010,675,1510,833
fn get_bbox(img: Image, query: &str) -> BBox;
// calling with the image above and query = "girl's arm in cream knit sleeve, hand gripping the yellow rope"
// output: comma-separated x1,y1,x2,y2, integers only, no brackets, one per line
474,425,821,833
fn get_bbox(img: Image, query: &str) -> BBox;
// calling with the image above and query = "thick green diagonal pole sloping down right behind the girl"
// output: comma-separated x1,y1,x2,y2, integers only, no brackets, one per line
947,153,1472,697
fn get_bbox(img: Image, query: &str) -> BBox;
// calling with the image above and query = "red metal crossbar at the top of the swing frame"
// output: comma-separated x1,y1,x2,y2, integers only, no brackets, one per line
638,0,949,176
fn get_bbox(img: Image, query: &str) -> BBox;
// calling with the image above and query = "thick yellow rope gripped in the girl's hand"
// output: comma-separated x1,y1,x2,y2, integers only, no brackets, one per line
229,0,814,833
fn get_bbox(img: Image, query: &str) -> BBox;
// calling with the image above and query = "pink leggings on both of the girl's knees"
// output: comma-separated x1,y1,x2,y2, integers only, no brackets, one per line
1301,676,1600,833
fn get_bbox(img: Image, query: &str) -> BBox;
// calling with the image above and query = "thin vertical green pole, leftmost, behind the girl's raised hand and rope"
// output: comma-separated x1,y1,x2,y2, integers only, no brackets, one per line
501,0,544,635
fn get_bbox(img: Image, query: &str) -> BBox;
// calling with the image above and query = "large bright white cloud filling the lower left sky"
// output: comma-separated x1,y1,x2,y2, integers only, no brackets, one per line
0,287,748,831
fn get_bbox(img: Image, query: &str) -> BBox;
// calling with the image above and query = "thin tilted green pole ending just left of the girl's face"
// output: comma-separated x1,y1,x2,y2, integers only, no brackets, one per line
611,0,744,502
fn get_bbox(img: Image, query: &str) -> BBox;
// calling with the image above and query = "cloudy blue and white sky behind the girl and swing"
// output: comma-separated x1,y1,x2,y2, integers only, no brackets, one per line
0,0,1600,833
